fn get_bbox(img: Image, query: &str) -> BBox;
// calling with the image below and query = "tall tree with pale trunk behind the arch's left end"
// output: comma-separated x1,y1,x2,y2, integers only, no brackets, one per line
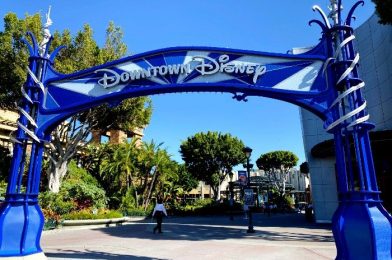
0,13,152,192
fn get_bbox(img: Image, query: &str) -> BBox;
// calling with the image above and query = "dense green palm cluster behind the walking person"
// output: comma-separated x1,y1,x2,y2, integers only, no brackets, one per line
81,139,198,211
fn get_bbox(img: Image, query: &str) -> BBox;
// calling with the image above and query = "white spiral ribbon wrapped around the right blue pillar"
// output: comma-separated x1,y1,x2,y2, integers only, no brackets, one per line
324,35,369,131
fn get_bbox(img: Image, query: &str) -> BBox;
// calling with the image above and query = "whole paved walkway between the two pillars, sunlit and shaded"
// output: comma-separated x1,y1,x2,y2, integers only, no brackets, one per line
42,214,336,260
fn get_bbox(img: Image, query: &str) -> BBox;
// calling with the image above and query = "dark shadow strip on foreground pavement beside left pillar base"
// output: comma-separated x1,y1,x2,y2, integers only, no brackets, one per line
45,250,168,260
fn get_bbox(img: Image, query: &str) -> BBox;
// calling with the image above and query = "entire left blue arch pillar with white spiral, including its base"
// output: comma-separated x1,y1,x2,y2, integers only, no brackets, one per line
0,34,44,256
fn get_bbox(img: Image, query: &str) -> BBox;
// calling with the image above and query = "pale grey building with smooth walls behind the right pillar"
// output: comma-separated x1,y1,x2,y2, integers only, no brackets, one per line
300,15,392,223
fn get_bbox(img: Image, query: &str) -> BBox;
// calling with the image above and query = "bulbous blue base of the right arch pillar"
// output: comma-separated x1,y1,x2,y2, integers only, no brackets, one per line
332,192,392,260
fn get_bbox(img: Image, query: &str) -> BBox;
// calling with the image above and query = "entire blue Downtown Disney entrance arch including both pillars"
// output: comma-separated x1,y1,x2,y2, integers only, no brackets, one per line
0,1,391,259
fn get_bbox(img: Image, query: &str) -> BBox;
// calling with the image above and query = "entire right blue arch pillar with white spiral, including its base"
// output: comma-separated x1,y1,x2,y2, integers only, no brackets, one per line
312,1,392,259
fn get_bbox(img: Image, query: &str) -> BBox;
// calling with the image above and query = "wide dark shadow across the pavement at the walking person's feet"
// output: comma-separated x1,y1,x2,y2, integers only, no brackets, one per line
94,215,334,243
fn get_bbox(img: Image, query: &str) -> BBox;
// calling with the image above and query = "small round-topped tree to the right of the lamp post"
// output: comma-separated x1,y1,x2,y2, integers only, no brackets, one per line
256,151,298,196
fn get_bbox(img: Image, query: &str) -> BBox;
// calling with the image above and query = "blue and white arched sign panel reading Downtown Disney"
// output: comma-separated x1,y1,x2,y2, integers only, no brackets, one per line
39,46,328,124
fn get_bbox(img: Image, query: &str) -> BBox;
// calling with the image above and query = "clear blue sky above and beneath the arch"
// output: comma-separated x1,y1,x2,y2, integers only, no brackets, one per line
0,0,374,167
